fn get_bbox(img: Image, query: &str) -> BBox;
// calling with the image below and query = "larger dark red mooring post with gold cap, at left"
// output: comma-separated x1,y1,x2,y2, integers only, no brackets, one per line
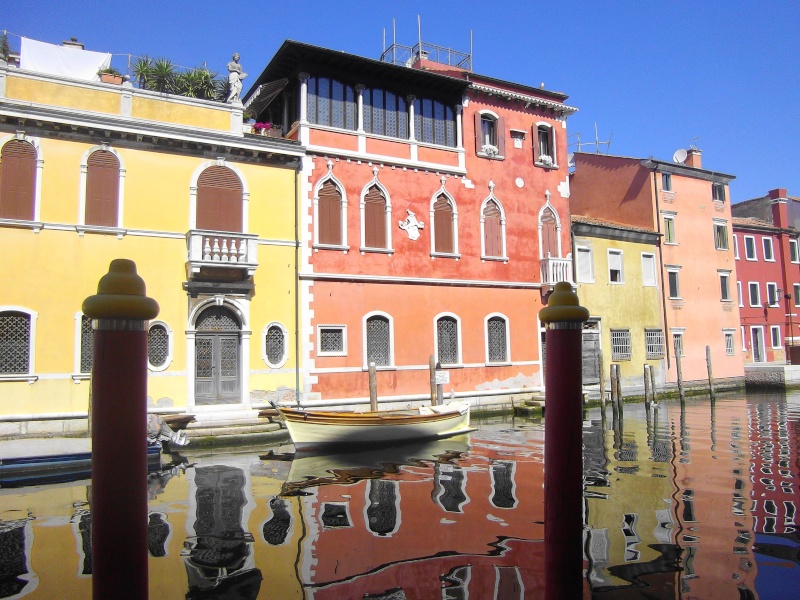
83,259,158,600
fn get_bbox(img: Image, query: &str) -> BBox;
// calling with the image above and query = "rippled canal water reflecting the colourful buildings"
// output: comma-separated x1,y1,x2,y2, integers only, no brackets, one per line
0,394,800,600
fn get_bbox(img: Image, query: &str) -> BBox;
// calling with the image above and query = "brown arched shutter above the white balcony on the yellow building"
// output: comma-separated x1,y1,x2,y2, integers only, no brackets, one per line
197,166,243,232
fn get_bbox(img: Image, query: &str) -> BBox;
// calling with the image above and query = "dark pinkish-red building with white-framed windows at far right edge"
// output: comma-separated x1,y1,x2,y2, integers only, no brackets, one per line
731,188,800,364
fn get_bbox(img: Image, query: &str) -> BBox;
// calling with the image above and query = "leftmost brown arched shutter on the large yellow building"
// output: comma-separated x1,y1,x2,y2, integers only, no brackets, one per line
0,140,36,221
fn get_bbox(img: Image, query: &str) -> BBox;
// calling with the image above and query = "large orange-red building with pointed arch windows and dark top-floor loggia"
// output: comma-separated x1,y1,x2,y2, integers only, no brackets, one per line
245,41,575,405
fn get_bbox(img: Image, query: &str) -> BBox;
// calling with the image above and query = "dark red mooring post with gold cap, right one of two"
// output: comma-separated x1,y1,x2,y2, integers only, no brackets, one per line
539,282,589,600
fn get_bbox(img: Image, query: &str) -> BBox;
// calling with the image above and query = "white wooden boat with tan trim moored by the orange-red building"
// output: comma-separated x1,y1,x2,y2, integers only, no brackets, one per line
276,402,474,450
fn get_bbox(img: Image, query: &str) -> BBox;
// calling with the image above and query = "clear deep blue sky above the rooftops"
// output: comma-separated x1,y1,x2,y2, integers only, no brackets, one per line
0,0,800,202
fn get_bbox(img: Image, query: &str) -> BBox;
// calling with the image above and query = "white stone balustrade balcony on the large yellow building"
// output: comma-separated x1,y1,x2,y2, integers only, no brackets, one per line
186,229,258,279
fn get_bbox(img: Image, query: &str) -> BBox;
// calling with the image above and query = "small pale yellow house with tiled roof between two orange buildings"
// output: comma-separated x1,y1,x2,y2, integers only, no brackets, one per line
572,216,665,390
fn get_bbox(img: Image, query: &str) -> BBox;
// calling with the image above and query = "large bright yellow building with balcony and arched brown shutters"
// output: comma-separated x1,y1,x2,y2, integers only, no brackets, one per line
0,51,303,435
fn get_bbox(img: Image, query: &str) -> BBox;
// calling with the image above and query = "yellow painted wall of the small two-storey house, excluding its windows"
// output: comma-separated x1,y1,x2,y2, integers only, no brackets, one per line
575,236,667,385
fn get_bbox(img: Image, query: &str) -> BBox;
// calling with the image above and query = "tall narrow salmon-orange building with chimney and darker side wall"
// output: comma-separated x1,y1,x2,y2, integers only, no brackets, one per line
570,149,744,386
